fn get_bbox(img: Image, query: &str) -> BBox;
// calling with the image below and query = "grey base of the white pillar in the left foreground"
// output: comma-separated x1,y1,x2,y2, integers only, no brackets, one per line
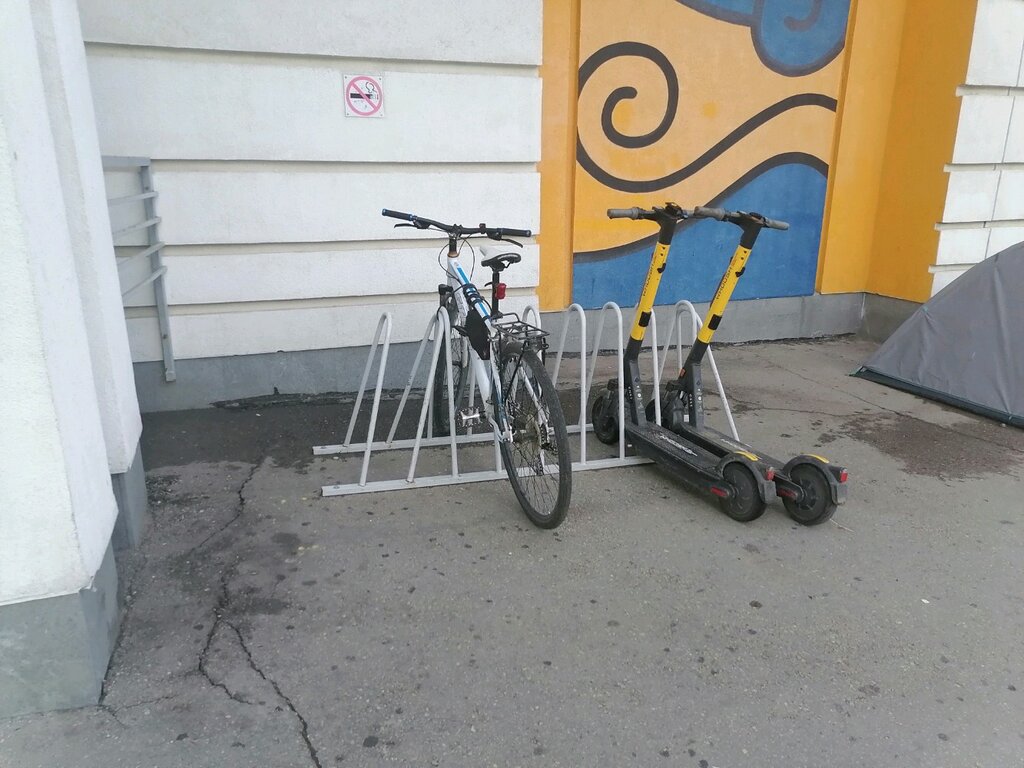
0,547,120,718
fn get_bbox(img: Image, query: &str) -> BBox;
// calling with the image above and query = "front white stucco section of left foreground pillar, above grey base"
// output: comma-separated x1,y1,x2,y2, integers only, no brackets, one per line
0,0,117,603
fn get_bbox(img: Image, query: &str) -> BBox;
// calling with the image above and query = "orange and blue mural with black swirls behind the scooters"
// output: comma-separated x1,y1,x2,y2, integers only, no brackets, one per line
572,0,849,307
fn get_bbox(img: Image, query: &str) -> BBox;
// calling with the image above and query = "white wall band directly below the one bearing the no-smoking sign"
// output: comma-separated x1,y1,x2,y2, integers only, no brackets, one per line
154,167,540,244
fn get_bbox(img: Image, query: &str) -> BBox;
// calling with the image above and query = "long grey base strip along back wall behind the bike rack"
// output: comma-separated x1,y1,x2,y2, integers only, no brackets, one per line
135,293,864,413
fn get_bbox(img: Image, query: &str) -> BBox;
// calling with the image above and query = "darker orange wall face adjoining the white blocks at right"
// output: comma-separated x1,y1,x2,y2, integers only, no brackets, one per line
861,0,977,301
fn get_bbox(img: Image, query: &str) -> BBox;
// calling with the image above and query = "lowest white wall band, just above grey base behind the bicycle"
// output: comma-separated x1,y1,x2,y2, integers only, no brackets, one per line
128,296,537,362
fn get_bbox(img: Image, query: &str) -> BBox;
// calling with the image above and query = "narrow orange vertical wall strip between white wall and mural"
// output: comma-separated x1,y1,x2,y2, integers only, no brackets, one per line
537,0,580,309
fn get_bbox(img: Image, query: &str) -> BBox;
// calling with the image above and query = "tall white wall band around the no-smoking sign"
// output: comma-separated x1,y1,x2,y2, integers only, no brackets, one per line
89,51,541,163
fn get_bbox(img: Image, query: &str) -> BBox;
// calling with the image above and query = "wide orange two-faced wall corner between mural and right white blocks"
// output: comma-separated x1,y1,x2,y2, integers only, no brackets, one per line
818,0,977,301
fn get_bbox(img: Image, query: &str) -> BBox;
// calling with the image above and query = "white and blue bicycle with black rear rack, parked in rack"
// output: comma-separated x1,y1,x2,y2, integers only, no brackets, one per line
381,208,572,528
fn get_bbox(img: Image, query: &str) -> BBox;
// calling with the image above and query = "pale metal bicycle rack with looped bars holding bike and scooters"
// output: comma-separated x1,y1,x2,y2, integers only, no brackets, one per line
312,301,738,496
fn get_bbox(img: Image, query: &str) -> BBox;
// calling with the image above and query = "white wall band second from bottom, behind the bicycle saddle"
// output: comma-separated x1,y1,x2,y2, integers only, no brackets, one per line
149,246,539,306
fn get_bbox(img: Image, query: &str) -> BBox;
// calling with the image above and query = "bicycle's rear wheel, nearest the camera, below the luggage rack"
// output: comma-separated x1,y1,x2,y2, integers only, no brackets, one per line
499,345,572,528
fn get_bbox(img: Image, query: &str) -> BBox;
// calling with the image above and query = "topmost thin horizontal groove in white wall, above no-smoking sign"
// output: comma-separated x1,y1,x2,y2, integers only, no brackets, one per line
85,40,540,78
